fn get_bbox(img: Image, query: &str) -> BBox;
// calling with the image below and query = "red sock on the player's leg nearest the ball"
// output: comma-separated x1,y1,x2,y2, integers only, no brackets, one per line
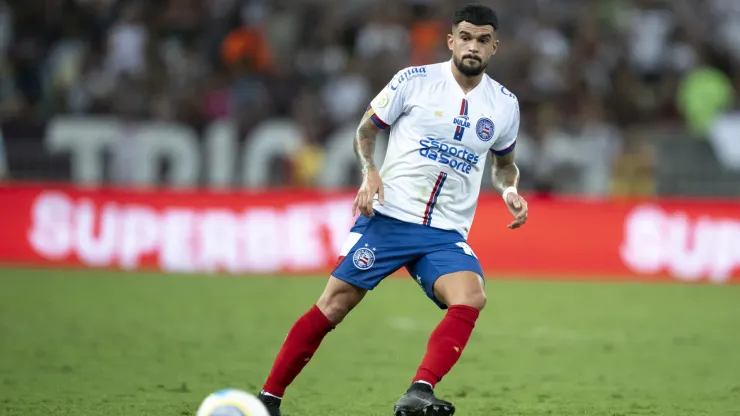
262,305,334,397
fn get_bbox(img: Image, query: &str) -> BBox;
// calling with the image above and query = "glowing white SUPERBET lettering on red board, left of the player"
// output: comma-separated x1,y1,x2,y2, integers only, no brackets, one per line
28,191,352,274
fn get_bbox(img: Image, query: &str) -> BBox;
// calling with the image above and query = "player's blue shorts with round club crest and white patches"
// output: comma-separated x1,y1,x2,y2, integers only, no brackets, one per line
332,212,483,309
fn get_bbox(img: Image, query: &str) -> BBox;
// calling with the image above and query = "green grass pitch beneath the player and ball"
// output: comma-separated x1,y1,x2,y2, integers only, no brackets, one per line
0,269,740,416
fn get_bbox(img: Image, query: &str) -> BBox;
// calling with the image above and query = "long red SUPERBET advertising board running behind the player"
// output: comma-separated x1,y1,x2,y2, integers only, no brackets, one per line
0,185,740,283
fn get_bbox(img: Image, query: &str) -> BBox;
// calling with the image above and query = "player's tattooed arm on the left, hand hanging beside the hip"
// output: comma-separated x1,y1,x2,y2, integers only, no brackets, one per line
352,108,383,217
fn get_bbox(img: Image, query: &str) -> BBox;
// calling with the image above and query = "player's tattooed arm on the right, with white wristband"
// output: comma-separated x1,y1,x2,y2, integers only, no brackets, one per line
491,150,529,229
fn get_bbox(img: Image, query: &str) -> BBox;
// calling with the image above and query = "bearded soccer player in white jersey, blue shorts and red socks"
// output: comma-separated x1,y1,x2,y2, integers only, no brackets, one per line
259,5,528,416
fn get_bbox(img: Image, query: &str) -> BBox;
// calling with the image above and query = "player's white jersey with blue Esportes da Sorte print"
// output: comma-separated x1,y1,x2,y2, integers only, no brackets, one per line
370,61,519,239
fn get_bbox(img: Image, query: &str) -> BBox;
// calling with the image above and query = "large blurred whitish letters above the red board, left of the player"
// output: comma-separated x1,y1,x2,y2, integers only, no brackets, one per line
44,116,370,188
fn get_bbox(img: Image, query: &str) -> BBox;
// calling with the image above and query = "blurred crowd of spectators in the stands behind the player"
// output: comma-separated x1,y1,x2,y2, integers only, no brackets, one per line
0,0,740,194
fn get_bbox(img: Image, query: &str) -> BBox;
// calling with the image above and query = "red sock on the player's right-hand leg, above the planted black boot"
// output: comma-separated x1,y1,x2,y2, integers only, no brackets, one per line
412,305,480,387
